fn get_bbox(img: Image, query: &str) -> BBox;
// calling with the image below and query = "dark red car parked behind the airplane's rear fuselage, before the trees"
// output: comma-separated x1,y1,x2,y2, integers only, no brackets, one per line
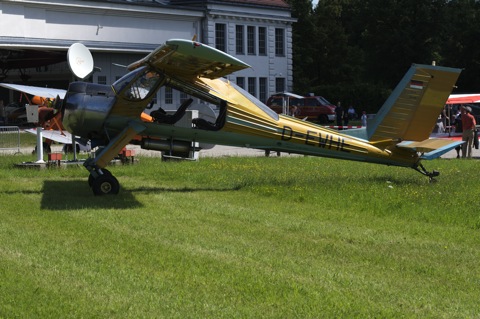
266,93,335,124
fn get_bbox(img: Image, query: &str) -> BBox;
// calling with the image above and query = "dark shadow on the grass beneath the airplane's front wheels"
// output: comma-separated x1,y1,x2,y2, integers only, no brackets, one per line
40,180,240,210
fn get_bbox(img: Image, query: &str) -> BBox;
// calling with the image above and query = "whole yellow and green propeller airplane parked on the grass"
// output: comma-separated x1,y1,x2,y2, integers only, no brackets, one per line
0,39,462,195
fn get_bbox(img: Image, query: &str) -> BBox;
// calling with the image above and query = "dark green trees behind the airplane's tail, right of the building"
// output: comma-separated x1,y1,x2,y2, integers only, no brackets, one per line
288,0,480,113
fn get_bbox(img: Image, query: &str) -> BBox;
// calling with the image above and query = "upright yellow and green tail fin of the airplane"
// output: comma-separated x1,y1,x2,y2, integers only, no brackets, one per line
367,64,461,142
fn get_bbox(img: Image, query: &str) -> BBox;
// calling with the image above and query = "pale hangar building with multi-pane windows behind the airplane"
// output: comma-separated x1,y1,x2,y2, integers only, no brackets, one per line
0,0,295,109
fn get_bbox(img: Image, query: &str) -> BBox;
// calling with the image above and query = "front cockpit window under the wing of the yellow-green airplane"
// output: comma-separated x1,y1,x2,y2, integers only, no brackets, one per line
113,67,164,101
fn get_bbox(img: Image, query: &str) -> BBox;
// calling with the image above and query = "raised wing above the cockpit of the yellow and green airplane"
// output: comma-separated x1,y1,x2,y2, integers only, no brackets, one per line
128,39,250,79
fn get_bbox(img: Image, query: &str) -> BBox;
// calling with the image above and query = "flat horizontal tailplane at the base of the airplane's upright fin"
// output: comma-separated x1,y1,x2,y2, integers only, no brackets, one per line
397,138,463,160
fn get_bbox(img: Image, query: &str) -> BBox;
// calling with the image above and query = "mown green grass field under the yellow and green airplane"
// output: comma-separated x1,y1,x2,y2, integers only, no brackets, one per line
0,156,480,318
